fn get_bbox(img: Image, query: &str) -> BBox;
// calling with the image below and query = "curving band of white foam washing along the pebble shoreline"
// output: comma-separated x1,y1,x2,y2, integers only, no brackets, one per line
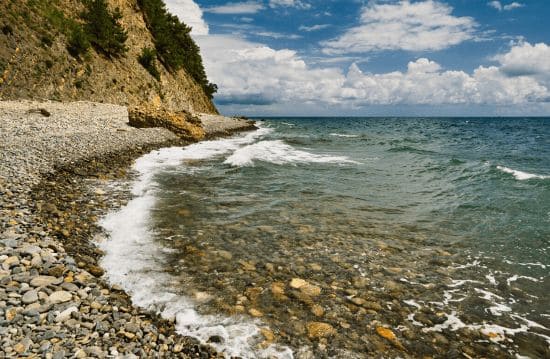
99,128,293,359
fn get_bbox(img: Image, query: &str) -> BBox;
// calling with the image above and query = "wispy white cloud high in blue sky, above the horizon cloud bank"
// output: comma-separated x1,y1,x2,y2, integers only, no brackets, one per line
323,0,476,54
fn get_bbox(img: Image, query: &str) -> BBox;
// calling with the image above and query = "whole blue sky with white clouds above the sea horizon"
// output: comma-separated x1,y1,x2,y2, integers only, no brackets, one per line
165,0,550,116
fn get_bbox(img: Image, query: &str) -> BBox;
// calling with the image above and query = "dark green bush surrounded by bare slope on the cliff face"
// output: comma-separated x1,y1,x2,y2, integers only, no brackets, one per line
82,0,128,57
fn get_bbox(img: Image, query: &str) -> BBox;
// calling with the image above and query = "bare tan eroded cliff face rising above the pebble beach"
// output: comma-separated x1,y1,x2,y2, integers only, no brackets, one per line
0,0,217,114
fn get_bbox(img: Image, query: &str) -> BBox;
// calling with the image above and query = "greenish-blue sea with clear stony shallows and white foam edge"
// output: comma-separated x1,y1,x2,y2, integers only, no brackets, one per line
99,117,550,358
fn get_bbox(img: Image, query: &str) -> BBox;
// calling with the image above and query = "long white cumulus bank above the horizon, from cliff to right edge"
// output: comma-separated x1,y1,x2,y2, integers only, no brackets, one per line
199,36,550,108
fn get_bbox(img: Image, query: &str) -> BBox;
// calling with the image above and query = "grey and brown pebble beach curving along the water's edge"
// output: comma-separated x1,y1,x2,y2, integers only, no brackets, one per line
0,102,252,358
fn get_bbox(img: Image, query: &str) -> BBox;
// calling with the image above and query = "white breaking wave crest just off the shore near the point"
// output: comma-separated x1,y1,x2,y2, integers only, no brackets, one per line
224,140,357,167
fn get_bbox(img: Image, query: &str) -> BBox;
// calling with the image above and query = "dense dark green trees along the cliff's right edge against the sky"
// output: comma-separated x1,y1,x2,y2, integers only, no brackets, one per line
138,0,218,98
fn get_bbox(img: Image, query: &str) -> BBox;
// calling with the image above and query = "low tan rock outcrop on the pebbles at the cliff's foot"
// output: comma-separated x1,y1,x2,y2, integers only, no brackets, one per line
128,106,205,141
